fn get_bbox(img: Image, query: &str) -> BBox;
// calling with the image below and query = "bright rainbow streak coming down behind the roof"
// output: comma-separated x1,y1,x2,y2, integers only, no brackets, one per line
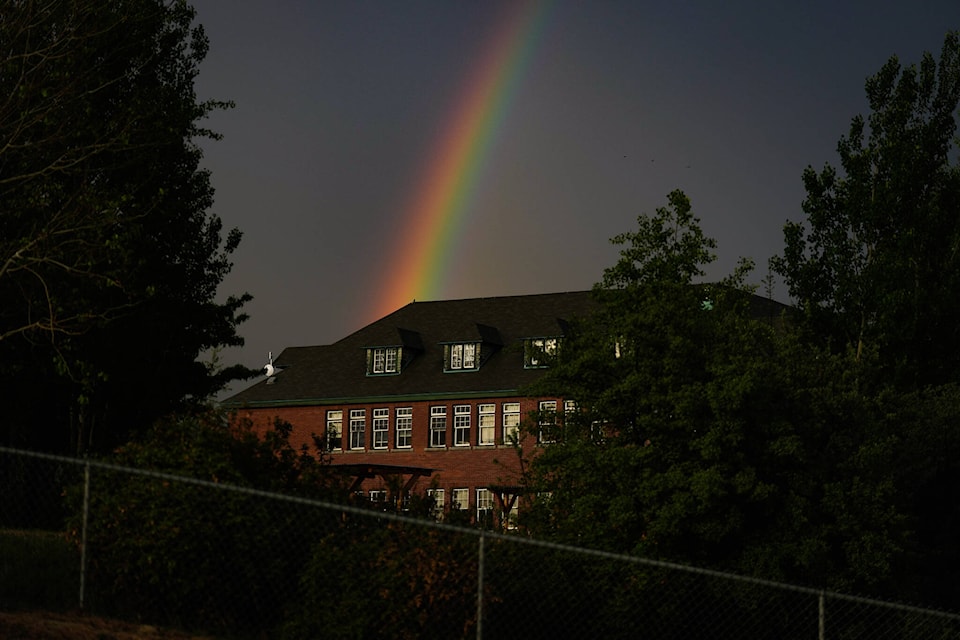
371,0,552,318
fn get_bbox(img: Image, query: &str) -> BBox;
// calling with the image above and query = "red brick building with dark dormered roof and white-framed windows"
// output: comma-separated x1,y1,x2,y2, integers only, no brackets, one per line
224,291,595,519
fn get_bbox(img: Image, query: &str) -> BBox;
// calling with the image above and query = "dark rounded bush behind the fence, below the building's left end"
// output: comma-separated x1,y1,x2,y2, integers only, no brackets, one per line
71,413,340,633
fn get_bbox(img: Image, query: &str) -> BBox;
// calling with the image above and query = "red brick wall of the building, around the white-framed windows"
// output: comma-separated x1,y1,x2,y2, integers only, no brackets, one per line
232,397,538,509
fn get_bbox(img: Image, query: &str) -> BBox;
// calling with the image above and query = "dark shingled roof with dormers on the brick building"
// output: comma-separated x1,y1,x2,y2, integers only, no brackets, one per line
224,291,596,407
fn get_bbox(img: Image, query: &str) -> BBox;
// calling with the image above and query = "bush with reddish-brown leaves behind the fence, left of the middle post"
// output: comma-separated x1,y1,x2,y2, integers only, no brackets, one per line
284,516,478,639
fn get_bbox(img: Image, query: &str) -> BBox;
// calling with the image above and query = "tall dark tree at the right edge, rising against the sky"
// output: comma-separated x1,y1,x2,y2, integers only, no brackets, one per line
771,32,960,606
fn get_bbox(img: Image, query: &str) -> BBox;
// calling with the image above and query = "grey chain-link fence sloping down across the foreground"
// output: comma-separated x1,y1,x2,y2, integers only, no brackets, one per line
0,448,960,640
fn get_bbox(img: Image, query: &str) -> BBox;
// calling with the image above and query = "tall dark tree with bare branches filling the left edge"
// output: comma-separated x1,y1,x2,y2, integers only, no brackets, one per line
0,0,250,451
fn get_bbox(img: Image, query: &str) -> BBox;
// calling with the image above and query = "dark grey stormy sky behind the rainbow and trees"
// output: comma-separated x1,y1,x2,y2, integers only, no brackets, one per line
194,0,960,396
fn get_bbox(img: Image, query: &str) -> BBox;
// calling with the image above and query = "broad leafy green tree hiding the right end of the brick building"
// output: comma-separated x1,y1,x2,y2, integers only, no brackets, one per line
521,192,928,595
